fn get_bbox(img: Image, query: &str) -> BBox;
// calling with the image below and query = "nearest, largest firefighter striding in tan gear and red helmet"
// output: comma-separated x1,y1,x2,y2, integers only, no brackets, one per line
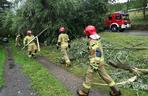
77,25,121,96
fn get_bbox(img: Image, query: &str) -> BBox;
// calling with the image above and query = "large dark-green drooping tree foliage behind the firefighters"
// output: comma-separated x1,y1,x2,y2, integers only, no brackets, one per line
2,0,108,41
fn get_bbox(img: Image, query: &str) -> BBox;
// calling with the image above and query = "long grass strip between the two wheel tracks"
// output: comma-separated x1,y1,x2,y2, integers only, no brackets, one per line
13,45,72,96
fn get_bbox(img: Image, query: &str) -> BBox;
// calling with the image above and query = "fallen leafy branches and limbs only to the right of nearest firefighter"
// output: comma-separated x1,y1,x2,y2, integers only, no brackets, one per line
103,39,148,90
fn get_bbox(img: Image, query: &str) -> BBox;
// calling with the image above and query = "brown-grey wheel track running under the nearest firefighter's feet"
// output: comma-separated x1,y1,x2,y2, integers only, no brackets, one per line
36,56,109,96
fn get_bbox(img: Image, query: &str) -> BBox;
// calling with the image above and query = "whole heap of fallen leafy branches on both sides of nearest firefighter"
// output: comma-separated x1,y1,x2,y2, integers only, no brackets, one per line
69,38,148,90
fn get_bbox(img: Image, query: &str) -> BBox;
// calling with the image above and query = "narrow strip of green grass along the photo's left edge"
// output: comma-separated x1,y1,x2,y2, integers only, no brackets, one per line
0,46,6,87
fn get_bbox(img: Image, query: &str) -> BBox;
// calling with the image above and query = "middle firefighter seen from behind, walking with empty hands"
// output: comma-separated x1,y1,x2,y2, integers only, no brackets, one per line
57,27,71,66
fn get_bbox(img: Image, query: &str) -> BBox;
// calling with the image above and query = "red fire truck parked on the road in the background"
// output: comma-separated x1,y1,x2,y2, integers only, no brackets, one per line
104,11,131,32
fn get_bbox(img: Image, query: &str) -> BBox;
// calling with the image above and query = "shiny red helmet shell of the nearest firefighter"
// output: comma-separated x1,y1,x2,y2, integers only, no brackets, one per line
84,25,96,36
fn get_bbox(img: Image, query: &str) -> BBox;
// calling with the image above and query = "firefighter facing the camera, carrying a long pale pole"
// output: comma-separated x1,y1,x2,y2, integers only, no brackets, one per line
23,30,37,58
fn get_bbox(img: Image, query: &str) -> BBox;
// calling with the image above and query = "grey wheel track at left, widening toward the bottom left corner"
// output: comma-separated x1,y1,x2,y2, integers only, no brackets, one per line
0,47,37,96
